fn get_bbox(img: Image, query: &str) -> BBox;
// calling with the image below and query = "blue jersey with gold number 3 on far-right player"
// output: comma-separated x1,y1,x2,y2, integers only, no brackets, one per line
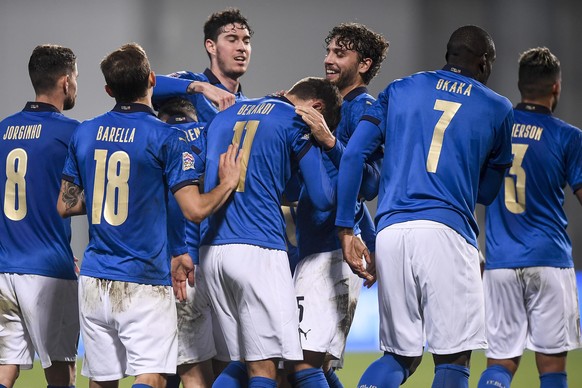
485,103,582,269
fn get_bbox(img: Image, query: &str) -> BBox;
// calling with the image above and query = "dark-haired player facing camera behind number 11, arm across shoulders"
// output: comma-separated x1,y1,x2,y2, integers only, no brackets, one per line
154,8,253,122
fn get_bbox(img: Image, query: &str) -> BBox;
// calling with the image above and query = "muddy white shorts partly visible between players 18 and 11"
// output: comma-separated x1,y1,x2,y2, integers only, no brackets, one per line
176,266,216,365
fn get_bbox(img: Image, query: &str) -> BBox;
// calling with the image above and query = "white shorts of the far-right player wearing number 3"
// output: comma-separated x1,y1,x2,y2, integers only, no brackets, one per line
483,267,582,359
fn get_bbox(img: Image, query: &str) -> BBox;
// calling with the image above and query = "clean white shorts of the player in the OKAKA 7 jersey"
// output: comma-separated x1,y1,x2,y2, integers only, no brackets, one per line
376,220,487,357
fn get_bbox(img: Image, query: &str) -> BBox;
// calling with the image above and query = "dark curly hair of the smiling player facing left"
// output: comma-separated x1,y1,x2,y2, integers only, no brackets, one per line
325,23,390,85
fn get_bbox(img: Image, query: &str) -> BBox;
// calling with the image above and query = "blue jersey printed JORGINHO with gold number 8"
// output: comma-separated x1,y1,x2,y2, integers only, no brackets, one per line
0,102,79,279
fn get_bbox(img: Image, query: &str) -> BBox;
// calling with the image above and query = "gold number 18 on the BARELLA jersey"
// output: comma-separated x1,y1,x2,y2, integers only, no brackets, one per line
91,150,129,226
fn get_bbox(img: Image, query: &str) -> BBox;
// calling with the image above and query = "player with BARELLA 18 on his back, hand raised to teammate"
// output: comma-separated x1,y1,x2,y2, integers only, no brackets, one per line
57,43,240,388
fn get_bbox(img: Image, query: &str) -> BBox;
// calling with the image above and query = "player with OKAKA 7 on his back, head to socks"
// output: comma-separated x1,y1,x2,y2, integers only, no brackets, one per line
336,26,513,388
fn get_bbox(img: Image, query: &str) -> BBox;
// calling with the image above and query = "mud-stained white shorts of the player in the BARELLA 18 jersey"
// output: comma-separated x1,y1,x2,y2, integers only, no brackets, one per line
79,276,178,381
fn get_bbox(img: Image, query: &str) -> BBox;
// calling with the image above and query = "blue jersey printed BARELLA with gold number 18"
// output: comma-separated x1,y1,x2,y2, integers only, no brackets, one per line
63,104,198,285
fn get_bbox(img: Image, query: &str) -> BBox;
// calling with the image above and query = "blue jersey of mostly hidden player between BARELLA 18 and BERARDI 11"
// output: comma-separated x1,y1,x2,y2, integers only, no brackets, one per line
167,116,206,264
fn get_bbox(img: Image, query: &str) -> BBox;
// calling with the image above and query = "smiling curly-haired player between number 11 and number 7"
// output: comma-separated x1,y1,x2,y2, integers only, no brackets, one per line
294,23,388,387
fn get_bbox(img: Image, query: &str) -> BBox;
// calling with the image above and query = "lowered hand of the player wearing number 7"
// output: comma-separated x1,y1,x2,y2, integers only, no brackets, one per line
338,228,376,287
